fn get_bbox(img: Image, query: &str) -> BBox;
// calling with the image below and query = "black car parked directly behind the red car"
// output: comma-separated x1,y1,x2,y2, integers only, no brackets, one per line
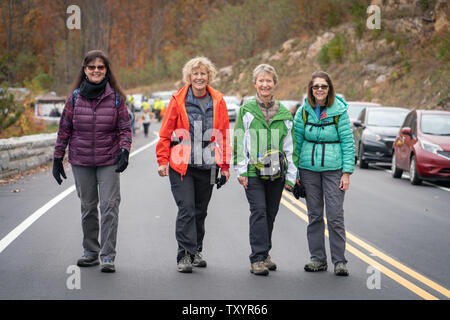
353,107,410,169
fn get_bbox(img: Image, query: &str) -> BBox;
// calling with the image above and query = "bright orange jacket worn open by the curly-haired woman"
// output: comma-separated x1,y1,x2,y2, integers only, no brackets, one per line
156,84,232,176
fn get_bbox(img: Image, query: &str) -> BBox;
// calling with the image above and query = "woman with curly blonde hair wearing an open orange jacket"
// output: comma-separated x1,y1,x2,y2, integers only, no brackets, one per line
156,57,231,273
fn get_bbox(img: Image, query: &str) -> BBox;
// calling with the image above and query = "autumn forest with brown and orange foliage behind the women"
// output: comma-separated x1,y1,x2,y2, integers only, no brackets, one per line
0,0,368,94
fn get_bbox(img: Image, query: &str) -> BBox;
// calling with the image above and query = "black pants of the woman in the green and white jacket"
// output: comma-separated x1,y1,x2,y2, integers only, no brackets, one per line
245,177,284,263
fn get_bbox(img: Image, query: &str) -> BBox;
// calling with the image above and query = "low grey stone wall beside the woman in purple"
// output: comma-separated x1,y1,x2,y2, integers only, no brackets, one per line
0,133,56,179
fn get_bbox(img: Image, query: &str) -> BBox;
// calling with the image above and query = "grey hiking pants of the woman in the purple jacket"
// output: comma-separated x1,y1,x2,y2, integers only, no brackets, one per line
72,165,120,261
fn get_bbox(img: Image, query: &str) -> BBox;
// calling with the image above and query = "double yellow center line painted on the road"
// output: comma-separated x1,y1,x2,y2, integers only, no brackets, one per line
281,192,442,300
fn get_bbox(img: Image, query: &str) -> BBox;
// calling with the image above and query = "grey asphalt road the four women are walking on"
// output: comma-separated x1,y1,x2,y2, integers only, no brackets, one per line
0,123,450,300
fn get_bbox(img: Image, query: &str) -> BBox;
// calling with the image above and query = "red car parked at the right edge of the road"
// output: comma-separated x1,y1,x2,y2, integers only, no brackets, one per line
392,110,450,184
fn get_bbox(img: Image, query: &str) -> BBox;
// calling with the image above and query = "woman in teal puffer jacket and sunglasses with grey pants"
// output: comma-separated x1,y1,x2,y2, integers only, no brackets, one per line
294,71,355,276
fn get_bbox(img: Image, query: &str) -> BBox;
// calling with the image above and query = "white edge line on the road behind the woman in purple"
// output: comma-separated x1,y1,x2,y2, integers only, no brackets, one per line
0,132,159,253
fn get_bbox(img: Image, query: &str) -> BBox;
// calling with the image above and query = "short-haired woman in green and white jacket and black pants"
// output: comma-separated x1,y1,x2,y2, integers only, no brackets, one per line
233,64,297,275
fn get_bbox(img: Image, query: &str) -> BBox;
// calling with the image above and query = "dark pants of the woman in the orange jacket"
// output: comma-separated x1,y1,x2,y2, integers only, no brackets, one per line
169,167,215,262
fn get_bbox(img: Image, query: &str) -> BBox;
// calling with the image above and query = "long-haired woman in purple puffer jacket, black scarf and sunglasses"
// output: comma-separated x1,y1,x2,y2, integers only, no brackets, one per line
53,50,132,272
